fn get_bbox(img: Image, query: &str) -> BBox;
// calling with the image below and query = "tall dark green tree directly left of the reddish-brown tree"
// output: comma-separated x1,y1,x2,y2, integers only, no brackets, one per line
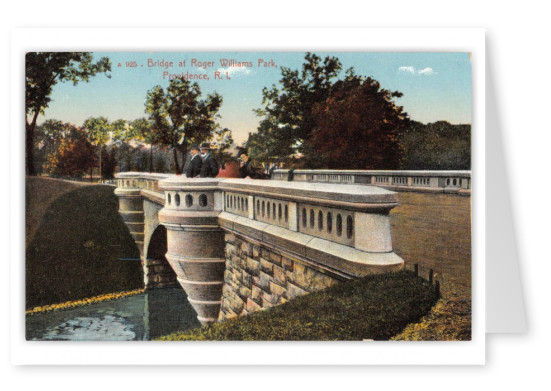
251,53,342,160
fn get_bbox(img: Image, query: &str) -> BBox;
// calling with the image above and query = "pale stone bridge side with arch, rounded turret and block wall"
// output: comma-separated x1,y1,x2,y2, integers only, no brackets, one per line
115,172,404,324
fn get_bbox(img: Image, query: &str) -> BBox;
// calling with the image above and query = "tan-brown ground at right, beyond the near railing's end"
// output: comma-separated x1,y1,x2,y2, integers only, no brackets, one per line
390,193,472,341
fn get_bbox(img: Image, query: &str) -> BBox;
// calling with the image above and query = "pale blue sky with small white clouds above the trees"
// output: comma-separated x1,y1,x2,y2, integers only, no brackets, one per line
39,52,472,145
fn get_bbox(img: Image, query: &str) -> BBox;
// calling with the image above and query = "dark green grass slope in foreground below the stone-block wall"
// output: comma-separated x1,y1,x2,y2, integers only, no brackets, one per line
159,271,437,341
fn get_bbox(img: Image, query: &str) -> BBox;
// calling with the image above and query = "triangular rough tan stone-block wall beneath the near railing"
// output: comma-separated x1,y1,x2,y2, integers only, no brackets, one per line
218,233,343,320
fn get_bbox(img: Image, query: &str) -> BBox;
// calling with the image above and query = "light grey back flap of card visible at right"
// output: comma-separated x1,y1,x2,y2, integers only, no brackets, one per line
486,48,526,333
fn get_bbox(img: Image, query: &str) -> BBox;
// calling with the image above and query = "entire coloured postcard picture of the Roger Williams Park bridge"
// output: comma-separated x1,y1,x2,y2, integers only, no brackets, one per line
25,50,472,343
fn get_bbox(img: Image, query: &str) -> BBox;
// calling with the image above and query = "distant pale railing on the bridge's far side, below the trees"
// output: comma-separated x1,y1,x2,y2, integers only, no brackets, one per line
272,169,471,194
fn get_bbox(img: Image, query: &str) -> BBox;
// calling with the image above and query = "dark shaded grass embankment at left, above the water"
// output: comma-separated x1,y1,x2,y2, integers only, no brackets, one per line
25,178,143,309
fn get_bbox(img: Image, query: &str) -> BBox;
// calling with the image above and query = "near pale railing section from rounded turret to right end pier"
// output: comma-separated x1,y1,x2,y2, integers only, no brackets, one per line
219,179,398,252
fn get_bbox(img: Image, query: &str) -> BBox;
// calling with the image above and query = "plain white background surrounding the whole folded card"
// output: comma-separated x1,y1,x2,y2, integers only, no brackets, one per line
0,0,551,391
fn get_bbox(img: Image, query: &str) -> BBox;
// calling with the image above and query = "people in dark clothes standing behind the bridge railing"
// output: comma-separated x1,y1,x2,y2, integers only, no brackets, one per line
184,143,269,179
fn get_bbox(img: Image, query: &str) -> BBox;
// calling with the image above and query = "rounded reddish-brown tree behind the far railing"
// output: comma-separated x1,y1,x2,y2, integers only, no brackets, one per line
304,76,409,170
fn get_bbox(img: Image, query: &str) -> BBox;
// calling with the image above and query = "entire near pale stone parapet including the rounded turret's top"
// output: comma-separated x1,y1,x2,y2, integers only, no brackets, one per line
116,172,406,272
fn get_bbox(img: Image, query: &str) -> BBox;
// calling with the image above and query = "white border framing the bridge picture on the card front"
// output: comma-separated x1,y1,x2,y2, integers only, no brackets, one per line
10,28,485,365
